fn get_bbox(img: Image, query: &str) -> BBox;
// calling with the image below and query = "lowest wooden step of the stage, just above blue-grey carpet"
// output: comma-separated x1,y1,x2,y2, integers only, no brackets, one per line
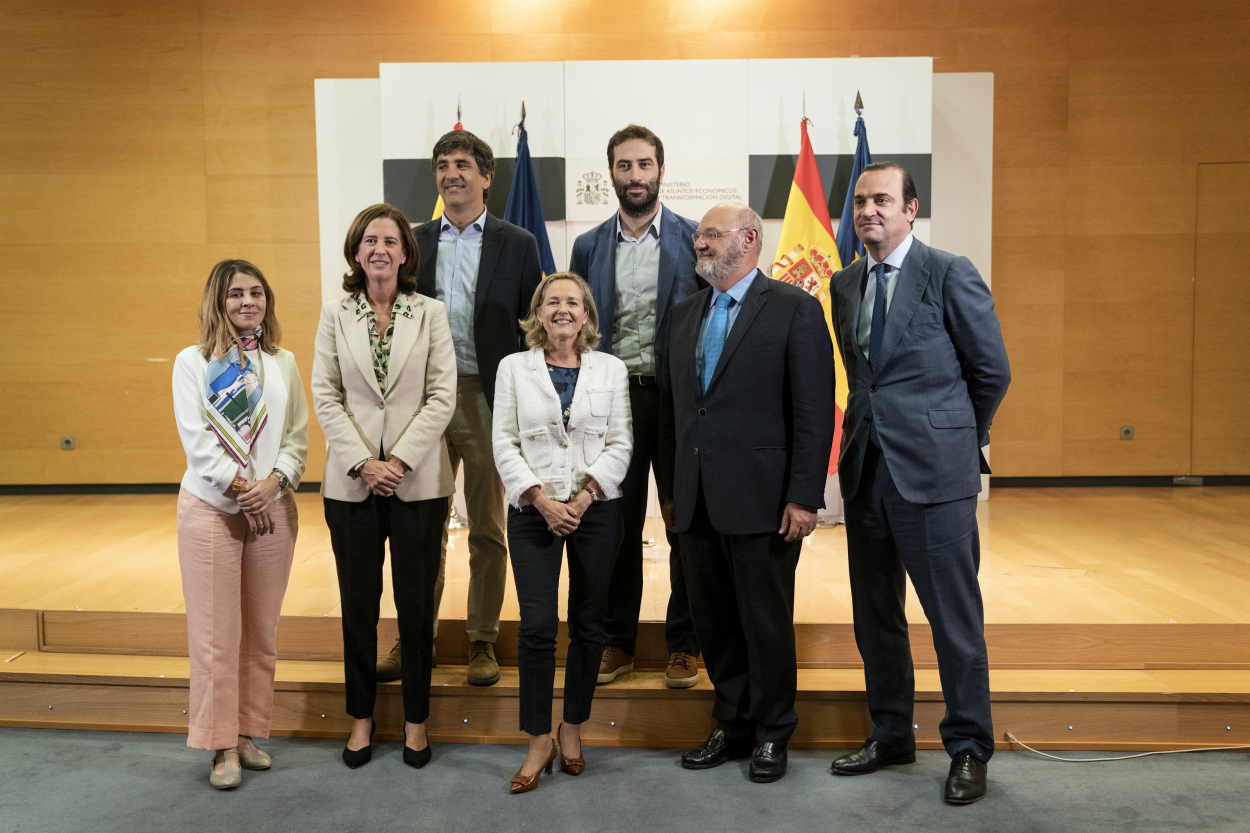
0,649,1250,749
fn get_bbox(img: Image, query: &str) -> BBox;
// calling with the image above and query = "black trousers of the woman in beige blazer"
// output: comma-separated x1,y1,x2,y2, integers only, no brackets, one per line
325,494,448,723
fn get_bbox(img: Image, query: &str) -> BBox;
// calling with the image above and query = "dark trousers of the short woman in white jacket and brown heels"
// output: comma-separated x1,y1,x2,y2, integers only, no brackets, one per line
508,500,620,734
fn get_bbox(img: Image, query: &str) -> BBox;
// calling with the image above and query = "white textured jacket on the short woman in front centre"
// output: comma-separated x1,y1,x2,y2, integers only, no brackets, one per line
491,348,634,507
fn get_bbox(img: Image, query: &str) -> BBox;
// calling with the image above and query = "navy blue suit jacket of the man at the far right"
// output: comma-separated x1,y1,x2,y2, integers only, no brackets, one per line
830,240,1011,503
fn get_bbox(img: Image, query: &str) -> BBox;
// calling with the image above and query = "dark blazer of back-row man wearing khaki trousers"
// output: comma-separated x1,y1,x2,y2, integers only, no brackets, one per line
413,214,543,408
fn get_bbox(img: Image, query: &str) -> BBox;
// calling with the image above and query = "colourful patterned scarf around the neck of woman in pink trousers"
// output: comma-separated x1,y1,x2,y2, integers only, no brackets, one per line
204,329,269,469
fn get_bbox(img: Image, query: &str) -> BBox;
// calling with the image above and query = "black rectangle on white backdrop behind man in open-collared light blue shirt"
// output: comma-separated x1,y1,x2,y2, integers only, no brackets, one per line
382,156,565,223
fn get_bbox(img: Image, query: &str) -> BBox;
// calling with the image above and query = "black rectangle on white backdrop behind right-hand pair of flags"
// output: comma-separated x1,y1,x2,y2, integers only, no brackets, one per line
750,154,933,223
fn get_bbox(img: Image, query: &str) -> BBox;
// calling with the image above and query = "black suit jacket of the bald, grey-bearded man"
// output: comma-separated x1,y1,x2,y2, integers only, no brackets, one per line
656,271,834,534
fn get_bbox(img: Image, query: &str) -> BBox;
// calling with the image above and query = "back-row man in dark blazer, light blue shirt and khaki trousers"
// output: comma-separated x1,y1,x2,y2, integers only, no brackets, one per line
379,130,543,685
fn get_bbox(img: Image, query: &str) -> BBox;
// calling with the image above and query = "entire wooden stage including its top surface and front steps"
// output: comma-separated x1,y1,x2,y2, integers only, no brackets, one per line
0,488,1250,749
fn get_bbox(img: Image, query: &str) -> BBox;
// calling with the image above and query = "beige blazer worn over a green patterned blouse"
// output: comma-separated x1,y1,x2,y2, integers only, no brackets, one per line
313,293,456,503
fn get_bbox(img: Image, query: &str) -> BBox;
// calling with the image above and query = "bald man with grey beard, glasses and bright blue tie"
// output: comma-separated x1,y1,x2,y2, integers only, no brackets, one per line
659,204,834,782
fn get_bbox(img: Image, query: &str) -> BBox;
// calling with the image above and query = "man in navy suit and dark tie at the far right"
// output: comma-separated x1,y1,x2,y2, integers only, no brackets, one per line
831,163,1011,804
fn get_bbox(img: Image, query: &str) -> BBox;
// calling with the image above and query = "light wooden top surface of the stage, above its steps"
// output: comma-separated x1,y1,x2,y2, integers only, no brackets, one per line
0,487,1250,624
